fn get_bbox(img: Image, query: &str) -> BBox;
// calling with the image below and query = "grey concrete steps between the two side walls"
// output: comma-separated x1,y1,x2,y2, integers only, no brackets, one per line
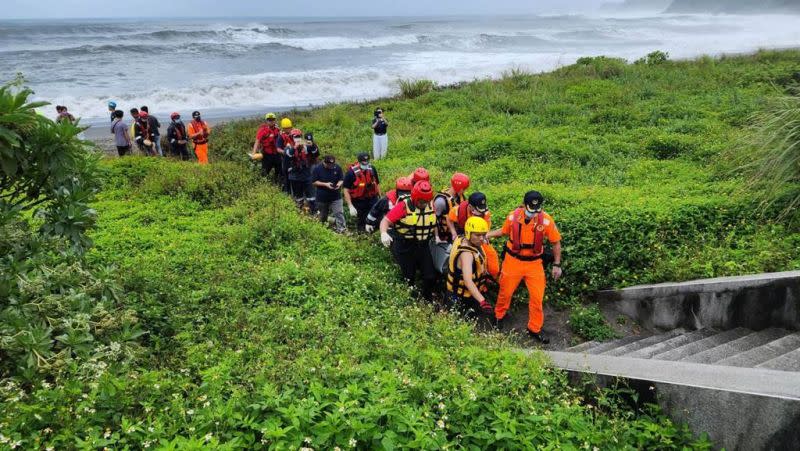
565,327,800,370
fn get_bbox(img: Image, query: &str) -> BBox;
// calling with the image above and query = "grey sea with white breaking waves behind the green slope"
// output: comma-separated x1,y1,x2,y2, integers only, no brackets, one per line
0,15,800,123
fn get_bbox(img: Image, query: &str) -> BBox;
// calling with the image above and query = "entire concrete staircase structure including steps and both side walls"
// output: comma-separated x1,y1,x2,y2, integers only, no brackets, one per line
547,271,800,451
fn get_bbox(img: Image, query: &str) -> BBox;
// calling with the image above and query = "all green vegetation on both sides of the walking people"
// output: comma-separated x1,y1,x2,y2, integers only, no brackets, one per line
0,51,800,449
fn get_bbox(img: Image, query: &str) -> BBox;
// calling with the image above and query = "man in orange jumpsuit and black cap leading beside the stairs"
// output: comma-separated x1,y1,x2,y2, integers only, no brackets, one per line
487,191,561,344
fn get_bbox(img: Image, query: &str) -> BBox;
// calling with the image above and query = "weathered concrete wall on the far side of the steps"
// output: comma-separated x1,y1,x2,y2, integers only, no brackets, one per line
597,271,800,330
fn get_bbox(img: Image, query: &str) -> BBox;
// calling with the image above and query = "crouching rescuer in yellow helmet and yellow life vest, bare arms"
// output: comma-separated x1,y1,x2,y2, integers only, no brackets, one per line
447,216,494,317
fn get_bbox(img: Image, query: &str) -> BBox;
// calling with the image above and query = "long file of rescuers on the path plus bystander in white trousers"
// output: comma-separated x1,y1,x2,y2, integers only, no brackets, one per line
251,109,561,344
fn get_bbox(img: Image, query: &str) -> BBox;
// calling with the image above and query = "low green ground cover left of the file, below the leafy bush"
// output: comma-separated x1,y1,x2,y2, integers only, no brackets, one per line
0,158,708,449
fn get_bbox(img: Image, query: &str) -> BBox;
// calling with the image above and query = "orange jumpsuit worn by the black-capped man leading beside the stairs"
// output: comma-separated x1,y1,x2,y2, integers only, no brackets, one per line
494,212,561,333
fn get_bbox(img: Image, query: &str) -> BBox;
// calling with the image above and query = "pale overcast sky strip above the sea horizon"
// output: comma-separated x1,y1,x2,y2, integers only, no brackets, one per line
0,0,608,19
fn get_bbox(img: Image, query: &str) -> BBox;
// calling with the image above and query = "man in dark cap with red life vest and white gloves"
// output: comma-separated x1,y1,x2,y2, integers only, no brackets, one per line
344,152,381,231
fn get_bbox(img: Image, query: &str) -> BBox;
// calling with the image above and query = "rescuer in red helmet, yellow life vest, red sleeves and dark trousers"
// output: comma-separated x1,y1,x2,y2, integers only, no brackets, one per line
380,181,437,301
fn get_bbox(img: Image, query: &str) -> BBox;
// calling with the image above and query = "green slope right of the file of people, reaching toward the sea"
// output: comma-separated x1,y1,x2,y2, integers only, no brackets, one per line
214,51,800,303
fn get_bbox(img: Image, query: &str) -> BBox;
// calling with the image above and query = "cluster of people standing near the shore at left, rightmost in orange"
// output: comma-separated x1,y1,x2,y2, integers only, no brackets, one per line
108,101,211,164
